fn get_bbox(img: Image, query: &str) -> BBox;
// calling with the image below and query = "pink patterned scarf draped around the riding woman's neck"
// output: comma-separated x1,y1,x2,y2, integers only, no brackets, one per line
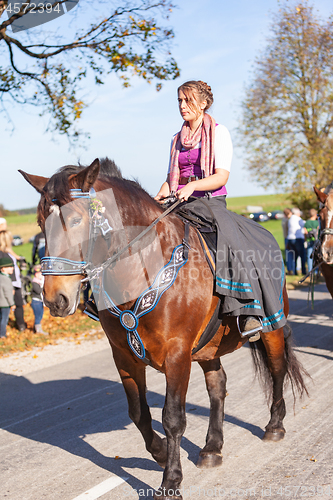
169,113,216,192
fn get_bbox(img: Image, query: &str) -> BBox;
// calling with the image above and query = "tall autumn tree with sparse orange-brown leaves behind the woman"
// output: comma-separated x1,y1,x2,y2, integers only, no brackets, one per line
239,0,333,208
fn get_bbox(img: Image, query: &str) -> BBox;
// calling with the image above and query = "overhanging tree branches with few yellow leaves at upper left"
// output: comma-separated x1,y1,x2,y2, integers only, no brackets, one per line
0,0,179,140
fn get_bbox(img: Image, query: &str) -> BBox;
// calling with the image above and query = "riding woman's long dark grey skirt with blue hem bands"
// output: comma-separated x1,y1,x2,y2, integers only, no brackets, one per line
180,196,286,332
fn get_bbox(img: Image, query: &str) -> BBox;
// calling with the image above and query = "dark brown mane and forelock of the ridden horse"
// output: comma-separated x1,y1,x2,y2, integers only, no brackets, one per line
37,157,159,226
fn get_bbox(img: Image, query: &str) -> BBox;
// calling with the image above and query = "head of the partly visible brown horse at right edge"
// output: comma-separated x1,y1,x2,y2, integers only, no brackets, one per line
313,187,333,265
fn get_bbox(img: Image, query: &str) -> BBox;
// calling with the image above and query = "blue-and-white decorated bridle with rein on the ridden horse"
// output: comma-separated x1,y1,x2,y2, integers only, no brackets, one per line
41,188,184,283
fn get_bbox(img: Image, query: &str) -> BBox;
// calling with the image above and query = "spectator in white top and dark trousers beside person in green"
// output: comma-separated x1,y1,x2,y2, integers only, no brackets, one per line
287,208,306,275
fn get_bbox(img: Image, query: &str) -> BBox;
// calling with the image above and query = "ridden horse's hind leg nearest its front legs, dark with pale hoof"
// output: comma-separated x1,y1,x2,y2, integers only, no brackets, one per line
197,359,227,469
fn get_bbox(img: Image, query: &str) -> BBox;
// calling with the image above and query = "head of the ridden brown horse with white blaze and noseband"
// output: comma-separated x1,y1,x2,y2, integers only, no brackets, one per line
19,159,100,317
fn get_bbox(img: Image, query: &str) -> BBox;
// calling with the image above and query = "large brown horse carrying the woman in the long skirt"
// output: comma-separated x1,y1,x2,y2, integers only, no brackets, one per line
21,160,306,500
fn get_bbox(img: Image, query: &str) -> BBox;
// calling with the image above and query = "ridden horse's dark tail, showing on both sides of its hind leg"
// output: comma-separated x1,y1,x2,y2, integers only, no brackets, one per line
249,323,311,403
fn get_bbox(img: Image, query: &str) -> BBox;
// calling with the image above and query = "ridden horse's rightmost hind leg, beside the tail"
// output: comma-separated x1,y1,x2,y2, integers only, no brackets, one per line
262,328,287,441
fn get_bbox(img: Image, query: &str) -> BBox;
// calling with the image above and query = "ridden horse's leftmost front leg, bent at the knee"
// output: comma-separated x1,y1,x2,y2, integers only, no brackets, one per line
112,346,167,467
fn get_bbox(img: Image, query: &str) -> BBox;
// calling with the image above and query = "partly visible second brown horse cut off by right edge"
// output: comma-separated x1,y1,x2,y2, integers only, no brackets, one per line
313,186,333,298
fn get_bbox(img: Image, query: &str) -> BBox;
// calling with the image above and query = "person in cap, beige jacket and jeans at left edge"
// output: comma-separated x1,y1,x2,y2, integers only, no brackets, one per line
0,256,14,337
